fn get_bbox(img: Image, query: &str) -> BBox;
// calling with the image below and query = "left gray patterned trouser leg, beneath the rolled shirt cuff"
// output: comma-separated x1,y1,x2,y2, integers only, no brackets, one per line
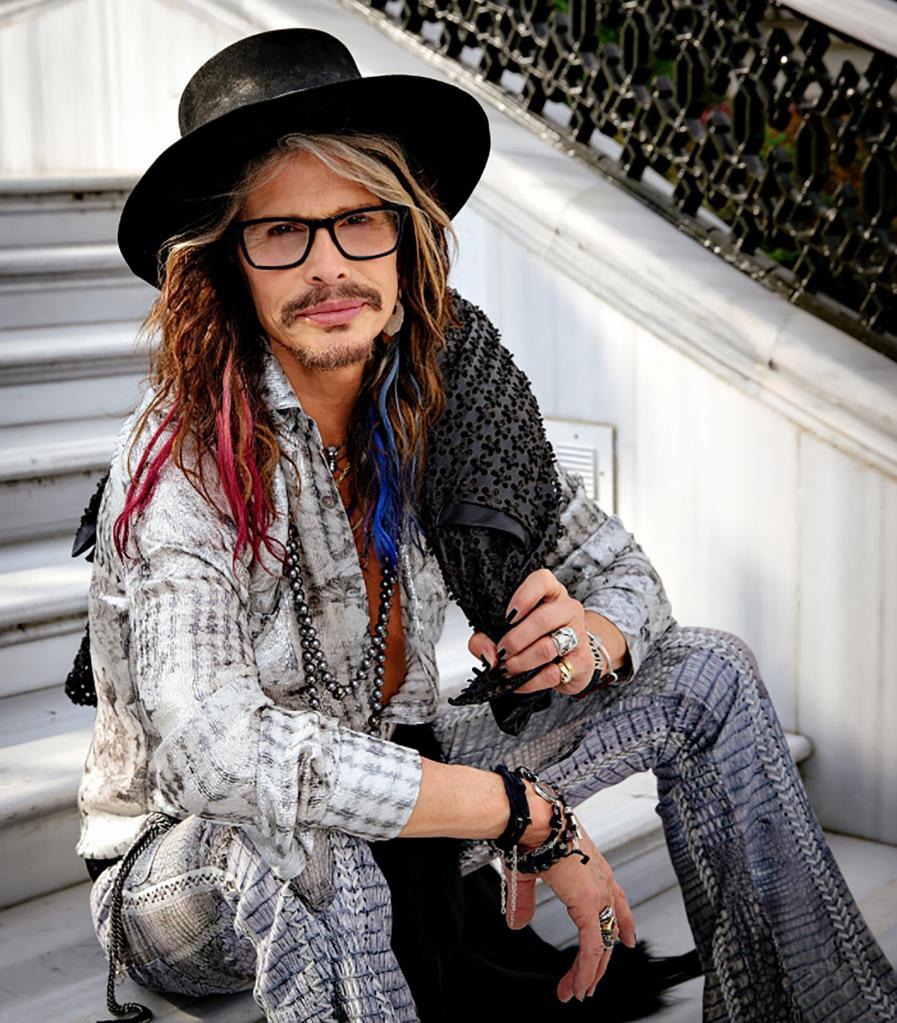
90,816,417,1023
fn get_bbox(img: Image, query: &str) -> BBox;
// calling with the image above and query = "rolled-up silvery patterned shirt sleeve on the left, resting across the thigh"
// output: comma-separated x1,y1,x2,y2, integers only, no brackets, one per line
119,460,421,877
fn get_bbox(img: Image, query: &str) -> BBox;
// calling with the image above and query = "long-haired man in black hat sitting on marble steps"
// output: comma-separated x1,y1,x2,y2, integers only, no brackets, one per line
77,24,897,1023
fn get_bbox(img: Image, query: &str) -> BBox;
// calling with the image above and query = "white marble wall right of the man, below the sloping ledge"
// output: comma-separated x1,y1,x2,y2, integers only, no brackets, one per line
453,202,897,842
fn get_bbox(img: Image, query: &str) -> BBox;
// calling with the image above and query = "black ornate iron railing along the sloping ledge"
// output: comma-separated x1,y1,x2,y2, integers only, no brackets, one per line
343,0,897,360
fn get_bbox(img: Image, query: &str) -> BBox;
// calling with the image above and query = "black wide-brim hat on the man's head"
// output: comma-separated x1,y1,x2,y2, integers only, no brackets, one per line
119,29,490,287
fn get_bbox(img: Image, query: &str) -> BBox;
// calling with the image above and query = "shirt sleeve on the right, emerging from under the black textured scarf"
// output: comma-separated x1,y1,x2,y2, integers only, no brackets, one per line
546,463,675,681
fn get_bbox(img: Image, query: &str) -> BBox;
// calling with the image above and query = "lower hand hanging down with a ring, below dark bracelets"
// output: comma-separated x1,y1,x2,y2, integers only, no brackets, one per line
502,822,635,1002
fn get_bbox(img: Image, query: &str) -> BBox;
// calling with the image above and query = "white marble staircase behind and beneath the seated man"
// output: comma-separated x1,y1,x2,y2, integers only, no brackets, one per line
0,177,859,1023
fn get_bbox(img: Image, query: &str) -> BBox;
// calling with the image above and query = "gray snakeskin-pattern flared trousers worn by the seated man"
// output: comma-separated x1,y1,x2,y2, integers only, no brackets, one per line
90,623,897,1023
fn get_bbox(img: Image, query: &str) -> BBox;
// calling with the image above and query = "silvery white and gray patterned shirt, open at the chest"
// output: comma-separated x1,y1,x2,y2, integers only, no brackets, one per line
76,293,673,879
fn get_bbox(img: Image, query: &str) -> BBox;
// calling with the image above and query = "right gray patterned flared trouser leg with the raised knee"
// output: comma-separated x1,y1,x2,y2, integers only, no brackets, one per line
438,624,897,1023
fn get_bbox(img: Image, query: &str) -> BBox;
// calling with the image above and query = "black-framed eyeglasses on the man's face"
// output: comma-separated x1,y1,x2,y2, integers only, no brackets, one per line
229,203,408,270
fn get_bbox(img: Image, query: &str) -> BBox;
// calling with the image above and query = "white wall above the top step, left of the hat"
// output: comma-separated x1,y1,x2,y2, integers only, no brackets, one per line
0,0,244,176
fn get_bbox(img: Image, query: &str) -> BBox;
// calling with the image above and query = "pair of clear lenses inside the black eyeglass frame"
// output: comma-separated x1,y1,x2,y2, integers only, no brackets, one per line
243,210,399,267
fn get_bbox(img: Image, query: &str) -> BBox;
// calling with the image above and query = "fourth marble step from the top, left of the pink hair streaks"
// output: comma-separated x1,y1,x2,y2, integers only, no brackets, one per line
0,416,122,544
